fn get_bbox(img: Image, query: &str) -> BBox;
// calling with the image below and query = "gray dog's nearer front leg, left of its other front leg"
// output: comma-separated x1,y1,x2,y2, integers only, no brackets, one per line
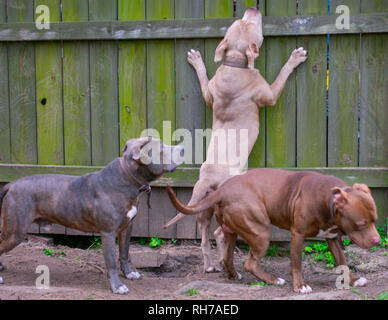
101,232,128,294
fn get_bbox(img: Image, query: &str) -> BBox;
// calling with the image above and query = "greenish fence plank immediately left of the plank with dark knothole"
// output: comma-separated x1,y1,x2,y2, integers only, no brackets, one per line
8,0,37,163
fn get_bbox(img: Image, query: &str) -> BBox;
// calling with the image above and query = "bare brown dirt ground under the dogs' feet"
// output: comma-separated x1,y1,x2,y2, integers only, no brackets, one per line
0,240,388,300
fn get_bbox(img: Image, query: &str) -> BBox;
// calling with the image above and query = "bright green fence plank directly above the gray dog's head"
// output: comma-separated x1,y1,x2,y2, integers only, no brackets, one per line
147,0,175,144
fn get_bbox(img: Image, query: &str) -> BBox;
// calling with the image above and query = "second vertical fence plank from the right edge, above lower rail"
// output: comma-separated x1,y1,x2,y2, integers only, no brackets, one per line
328,0,360,167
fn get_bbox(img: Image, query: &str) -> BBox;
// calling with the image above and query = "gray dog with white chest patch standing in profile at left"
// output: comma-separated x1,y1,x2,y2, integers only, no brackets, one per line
0,137,184,294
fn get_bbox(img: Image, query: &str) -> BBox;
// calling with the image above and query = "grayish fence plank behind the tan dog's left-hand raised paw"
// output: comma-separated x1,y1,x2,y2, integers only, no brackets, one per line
175,0,206,239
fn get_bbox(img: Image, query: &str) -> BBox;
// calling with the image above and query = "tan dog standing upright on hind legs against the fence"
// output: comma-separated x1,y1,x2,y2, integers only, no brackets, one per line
164,8,307,272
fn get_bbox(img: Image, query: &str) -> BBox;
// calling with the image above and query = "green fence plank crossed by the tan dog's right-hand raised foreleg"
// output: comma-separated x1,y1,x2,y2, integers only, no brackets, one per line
266,0,296,167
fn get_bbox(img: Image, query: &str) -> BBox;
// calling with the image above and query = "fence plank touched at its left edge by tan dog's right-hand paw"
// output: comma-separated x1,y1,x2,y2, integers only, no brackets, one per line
297,0,328,167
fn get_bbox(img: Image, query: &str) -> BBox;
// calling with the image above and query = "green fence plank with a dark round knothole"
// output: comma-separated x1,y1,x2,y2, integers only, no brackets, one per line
35,0,64,165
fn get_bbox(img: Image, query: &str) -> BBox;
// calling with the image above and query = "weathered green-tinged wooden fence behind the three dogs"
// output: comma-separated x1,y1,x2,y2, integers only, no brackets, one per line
0,0,388,240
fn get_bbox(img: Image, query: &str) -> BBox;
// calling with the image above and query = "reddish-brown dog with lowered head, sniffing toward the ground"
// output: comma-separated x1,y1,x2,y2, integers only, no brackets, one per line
168,169,380,293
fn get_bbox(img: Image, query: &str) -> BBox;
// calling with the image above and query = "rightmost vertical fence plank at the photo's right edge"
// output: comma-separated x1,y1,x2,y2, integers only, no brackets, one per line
360,0,388,166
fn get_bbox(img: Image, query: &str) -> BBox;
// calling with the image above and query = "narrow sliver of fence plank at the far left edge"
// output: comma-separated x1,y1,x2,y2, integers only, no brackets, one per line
0,41,11,163
